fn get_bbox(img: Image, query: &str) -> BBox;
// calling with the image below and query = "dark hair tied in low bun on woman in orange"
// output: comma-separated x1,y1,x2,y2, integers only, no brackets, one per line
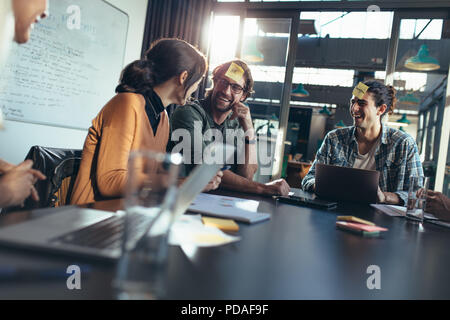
116,38,207,93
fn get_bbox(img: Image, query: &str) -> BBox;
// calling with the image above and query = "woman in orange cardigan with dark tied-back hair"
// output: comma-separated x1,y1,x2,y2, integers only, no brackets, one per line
71,39,210,204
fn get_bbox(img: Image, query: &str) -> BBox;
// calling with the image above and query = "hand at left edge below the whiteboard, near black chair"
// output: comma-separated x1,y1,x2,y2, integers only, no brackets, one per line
0,160,46,207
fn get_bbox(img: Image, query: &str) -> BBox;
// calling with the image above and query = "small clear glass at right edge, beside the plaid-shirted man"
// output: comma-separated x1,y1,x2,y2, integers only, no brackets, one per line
406,176,429,223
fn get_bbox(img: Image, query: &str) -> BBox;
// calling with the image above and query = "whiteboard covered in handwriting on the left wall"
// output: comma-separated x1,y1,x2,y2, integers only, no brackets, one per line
0,0,129,129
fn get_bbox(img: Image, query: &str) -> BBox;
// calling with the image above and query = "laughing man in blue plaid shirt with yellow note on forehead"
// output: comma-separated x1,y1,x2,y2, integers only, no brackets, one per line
302,80,423,205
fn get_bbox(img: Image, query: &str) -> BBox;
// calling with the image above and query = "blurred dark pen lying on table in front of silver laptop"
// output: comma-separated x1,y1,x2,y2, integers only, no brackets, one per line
0,266,90,282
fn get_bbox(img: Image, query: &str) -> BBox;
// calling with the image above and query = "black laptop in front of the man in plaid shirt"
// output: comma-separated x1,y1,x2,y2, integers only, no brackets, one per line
315,163,380,203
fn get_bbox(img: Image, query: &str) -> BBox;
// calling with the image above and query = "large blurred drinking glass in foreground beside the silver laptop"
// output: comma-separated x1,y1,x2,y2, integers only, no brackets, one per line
113,151,182,299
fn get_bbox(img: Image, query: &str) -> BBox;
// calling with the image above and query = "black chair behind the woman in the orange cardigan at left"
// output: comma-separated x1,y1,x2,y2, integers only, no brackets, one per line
5,146,82,212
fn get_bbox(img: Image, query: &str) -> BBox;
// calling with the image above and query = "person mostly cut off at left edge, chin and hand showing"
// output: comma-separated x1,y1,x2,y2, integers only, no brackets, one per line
0,0,48,209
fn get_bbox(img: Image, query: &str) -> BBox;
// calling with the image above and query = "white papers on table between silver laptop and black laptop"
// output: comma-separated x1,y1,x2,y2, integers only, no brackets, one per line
188,193,270,223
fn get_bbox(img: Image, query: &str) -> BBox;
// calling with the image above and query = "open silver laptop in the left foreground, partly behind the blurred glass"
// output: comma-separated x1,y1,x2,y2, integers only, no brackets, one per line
0,143,234,261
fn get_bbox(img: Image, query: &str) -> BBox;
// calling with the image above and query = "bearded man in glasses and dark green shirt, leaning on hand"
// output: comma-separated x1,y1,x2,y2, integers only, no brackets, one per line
169,60,290,195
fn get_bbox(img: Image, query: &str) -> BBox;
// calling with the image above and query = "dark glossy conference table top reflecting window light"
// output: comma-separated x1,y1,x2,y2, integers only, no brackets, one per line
0,191,450,300
